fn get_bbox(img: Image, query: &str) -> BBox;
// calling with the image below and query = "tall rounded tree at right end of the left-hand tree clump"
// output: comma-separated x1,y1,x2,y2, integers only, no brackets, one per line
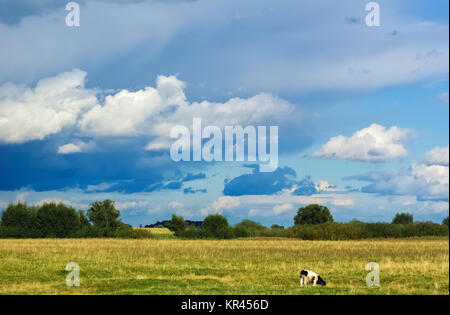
87,199,123,229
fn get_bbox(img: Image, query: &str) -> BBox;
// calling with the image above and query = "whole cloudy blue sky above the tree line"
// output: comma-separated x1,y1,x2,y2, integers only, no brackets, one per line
0,0,449,226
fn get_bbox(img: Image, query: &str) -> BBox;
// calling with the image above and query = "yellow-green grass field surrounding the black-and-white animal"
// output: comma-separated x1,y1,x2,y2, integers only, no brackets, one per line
0,238,449,294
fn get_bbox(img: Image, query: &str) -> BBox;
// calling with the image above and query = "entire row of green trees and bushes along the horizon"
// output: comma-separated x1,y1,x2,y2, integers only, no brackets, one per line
0,200,449,240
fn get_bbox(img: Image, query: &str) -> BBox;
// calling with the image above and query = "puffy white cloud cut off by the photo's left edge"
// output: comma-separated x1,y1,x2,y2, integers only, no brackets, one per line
0,69,97,143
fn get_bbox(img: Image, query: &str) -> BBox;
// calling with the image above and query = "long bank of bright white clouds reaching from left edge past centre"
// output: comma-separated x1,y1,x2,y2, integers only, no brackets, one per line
0,70,294,146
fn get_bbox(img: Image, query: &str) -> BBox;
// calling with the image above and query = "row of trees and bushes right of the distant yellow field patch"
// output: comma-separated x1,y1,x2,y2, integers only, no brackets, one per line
166,204,449,240
